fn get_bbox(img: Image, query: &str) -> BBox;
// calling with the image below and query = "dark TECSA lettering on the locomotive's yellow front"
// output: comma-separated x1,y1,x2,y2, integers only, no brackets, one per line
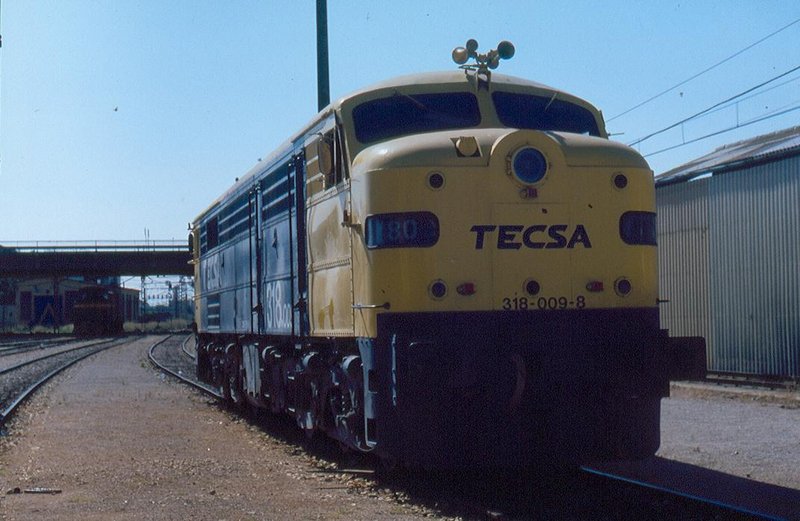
470,224,592,250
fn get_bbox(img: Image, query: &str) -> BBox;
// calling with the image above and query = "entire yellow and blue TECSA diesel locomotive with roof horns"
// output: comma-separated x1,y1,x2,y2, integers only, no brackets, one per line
189,41,705,467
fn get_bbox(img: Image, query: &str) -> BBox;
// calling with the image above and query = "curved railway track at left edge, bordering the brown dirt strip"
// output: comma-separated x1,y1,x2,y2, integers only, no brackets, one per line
0,338,127,426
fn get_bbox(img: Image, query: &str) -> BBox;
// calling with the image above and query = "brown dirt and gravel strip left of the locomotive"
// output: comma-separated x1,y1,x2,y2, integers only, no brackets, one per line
0,337,433,521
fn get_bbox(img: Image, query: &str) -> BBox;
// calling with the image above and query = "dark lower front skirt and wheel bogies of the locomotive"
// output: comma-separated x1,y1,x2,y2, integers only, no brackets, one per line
198,308,675,468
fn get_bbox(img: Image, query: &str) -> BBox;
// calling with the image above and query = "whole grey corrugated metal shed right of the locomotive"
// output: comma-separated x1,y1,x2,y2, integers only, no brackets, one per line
656,127,800,380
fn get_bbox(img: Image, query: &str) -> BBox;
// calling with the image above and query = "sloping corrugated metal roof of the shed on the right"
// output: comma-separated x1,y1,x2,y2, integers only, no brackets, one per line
656,126,800,186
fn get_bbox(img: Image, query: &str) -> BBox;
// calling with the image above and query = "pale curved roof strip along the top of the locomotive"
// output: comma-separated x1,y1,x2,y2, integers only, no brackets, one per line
195,69,602,222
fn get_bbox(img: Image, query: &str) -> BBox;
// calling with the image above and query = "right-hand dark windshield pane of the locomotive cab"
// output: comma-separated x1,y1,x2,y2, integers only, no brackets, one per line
492,91,600,136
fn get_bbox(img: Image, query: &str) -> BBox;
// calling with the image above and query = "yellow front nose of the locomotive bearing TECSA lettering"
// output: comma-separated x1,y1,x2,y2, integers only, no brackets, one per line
354,125,656,322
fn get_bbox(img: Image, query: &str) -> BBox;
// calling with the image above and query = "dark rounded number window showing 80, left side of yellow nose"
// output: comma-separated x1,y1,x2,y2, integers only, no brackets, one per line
365,212,439,250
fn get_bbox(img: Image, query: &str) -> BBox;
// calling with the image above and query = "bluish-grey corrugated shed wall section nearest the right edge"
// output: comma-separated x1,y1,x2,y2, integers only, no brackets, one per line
709,157,800,378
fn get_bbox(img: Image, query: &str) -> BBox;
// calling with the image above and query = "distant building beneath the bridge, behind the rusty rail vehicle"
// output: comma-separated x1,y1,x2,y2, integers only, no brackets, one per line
0,277,139,332
